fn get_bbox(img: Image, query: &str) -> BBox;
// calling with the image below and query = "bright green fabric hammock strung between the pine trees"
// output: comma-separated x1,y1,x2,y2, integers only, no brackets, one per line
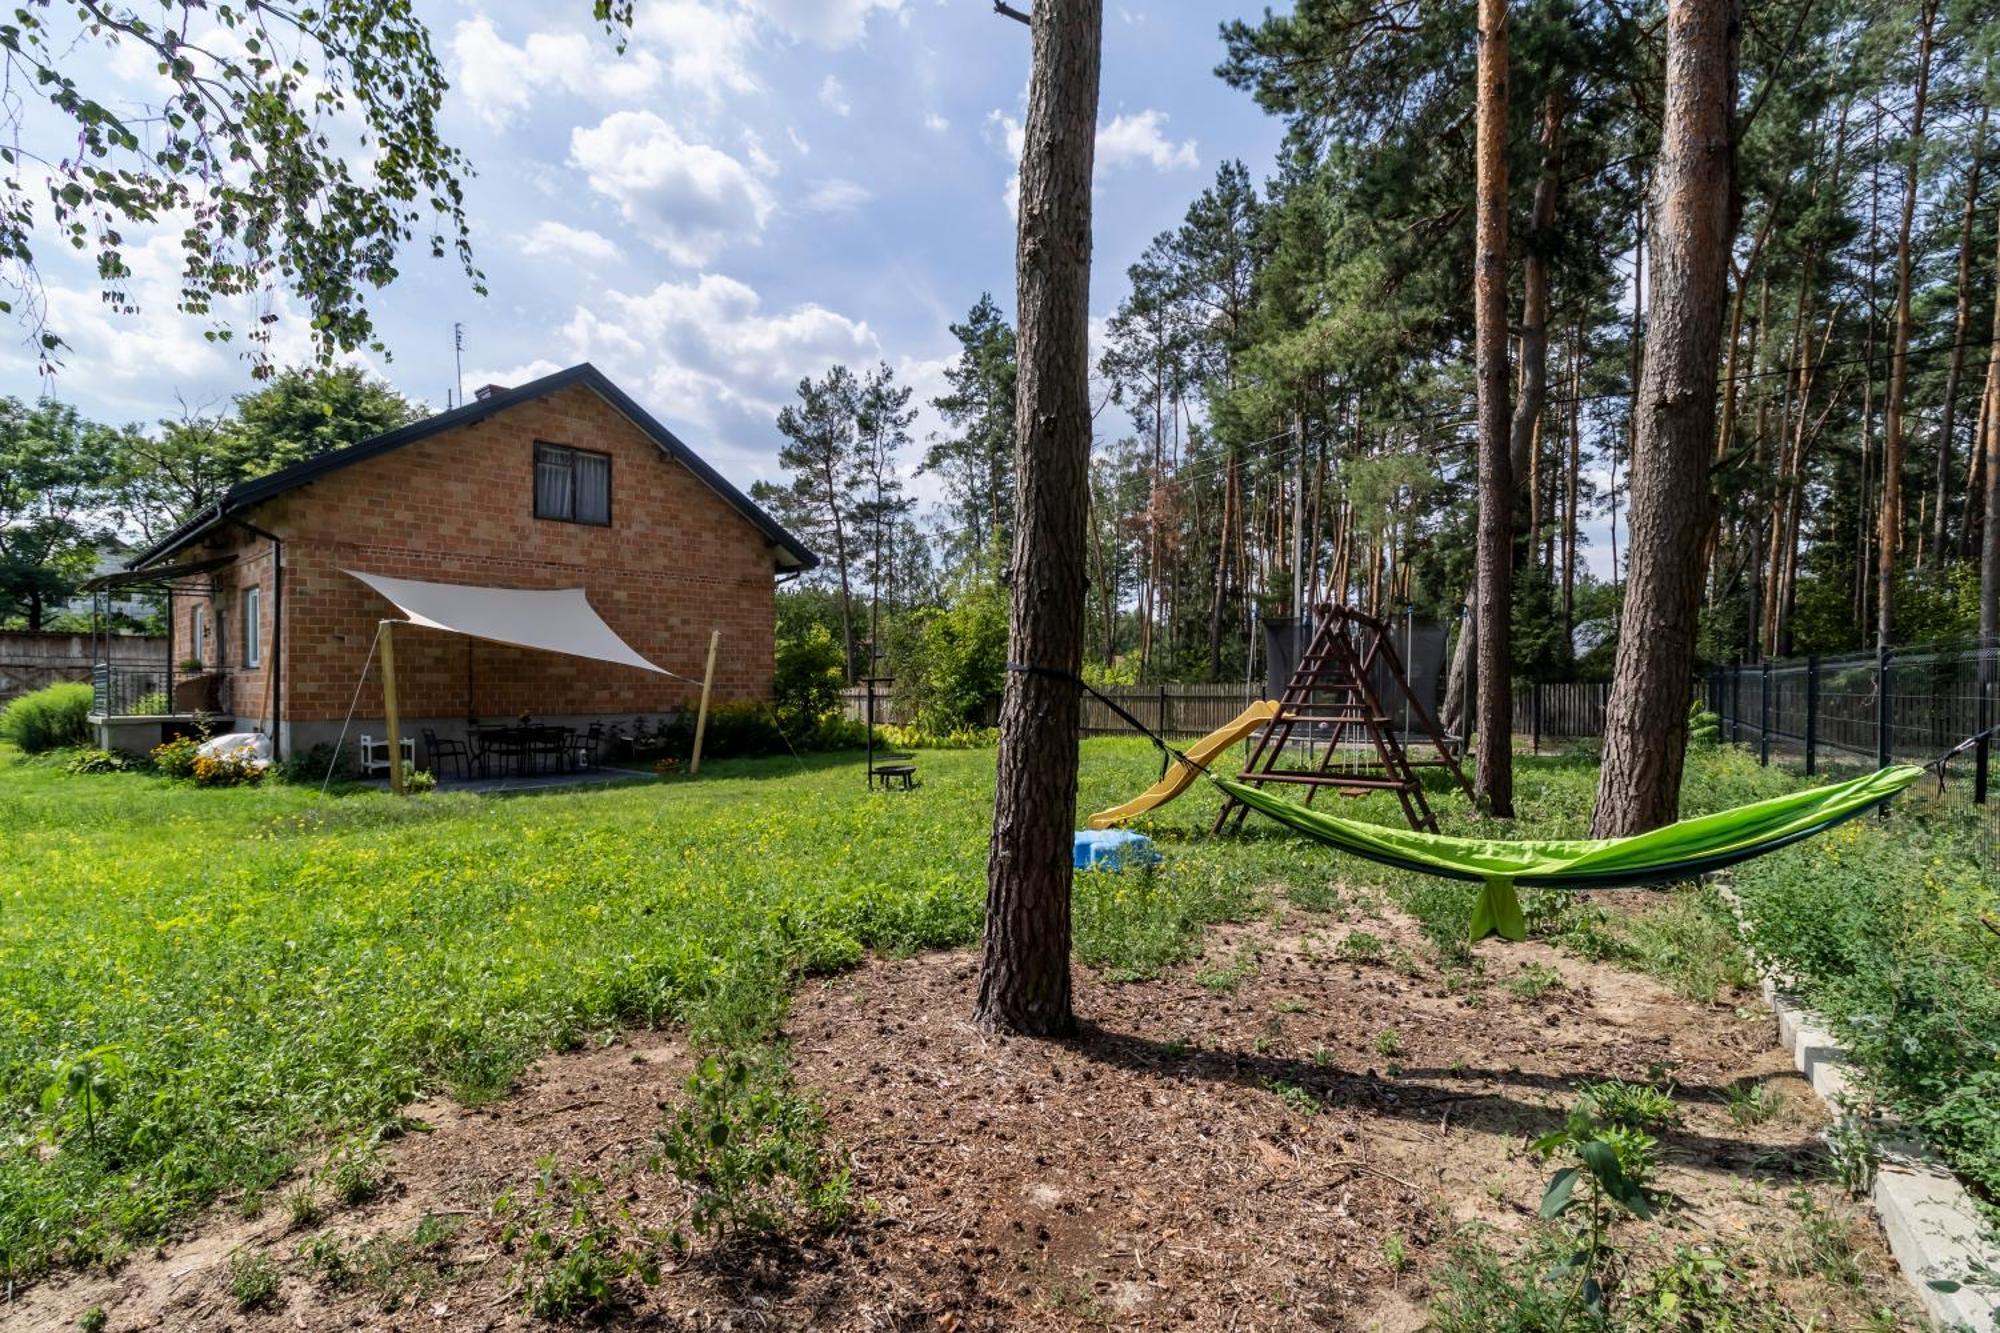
1210,765,1924,939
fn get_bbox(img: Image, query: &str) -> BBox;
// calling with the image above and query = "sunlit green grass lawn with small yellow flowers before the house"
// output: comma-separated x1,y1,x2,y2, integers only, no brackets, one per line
0,741,1984,1279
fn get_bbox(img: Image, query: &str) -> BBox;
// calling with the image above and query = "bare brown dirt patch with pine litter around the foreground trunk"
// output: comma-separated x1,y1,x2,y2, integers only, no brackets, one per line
11,896,1916,1333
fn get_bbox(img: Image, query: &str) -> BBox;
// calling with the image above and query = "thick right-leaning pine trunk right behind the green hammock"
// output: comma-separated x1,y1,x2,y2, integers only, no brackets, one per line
1592,0,1742,837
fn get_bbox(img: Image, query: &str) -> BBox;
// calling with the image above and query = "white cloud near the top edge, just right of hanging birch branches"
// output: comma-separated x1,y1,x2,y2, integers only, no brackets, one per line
452,18,660,128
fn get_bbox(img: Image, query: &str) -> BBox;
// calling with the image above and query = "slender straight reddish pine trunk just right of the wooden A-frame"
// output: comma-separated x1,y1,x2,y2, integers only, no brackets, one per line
1472,0,1514,819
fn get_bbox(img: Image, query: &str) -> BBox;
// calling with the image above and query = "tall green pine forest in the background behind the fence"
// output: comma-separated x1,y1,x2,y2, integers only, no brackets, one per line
762,0,2000,720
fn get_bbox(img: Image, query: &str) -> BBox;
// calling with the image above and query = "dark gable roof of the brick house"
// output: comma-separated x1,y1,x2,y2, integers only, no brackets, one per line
126,360,820,570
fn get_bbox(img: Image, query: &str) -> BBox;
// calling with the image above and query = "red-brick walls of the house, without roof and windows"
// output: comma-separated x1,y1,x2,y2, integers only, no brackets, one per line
160,386,774,735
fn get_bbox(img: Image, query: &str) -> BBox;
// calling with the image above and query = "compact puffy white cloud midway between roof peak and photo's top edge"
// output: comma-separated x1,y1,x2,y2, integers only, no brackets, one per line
570,112,774,266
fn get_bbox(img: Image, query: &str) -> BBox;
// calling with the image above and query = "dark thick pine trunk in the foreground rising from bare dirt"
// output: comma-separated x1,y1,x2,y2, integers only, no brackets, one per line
974,0,1104,1037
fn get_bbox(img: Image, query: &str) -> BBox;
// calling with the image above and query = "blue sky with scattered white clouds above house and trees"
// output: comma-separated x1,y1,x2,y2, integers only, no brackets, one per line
0,0,1280,510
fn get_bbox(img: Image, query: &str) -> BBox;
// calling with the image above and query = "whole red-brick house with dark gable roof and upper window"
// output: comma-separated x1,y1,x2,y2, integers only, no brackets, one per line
84,364,818,753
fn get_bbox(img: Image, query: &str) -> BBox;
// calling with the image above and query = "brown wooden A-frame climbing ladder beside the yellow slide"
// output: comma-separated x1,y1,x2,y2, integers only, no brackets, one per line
1216,606,1472,833
